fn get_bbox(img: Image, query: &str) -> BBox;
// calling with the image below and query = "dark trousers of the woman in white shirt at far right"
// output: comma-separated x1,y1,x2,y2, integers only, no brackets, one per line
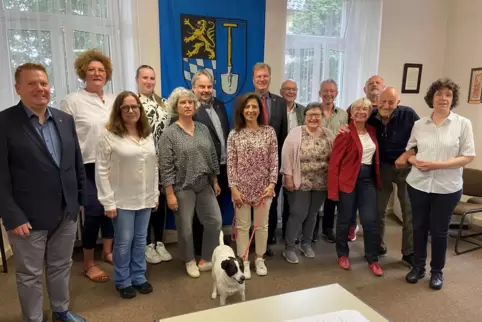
407,185,462,273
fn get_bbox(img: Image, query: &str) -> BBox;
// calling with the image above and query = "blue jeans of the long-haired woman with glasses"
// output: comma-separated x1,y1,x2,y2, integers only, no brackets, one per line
113,208,151,289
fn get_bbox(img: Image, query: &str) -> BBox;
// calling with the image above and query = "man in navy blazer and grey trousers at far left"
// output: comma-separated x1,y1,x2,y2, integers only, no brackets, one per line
0,63,86,322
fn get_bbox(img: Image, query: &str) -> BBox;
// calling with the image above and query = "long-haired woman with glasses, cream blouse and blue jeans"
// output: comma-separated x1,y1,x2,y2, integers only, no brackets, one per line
95,92,159,298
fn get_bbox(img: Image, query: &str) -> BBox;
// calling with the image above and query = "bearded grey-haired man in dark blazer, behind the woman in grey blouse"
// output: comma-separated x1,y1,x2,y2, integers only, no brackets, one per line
191,69,229,271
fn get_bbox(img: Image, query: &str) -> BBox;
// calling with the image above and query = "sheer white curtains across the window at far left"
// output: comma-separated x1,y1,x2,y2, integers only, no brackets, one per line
0,0,138,110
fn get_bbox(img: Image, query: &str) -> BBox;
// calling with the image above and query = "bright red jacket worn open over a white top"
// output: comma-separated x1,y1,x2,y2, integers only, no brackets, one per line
328,122,381,200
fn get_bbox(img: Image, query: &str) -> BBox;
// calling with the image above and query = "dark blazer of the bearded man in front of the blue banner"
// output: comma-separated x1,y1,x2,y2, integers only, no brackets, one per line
194,98,229,162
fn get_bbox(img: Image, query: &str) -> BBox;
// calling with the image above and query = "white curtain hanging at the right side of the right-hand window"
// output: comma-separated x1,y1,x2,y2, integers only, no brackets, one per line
340,0,383,108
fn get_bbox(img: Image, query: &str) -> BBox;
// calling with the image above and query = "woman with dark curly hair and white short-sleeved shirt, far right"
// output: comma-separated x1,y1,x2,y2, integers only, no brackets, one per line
406,78,475,290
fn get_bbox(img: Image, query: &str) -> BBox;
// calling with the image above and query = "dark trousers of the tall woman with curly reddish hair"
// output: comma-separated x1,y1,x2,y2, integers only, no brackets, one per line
82,163,114,249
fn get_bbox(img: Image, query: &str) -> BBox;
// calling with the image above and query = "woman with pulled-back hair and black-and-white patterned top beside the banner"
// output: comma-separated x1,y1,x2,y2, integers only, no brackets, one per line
136,65,172,264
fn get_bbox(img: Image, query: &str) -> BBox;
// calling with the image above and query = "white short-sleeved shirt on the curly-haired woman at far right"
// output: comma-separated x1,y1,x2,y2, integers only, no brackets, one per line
406,112,475,194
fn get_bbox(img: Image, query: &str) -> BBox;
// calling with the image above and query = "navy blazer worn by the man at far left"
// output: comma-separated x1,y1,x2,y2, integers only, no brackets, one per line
0,103,85,231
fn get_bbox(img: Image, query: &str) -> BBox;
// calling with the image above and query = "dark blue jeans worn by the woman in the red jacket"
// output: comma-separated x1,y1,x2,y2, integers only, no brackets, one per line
336,164,380,264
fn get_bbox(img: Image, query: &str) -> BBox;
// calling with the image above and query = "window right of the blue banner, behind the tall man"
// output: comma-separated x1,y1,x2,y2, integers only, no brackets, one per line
285,0,350,105
